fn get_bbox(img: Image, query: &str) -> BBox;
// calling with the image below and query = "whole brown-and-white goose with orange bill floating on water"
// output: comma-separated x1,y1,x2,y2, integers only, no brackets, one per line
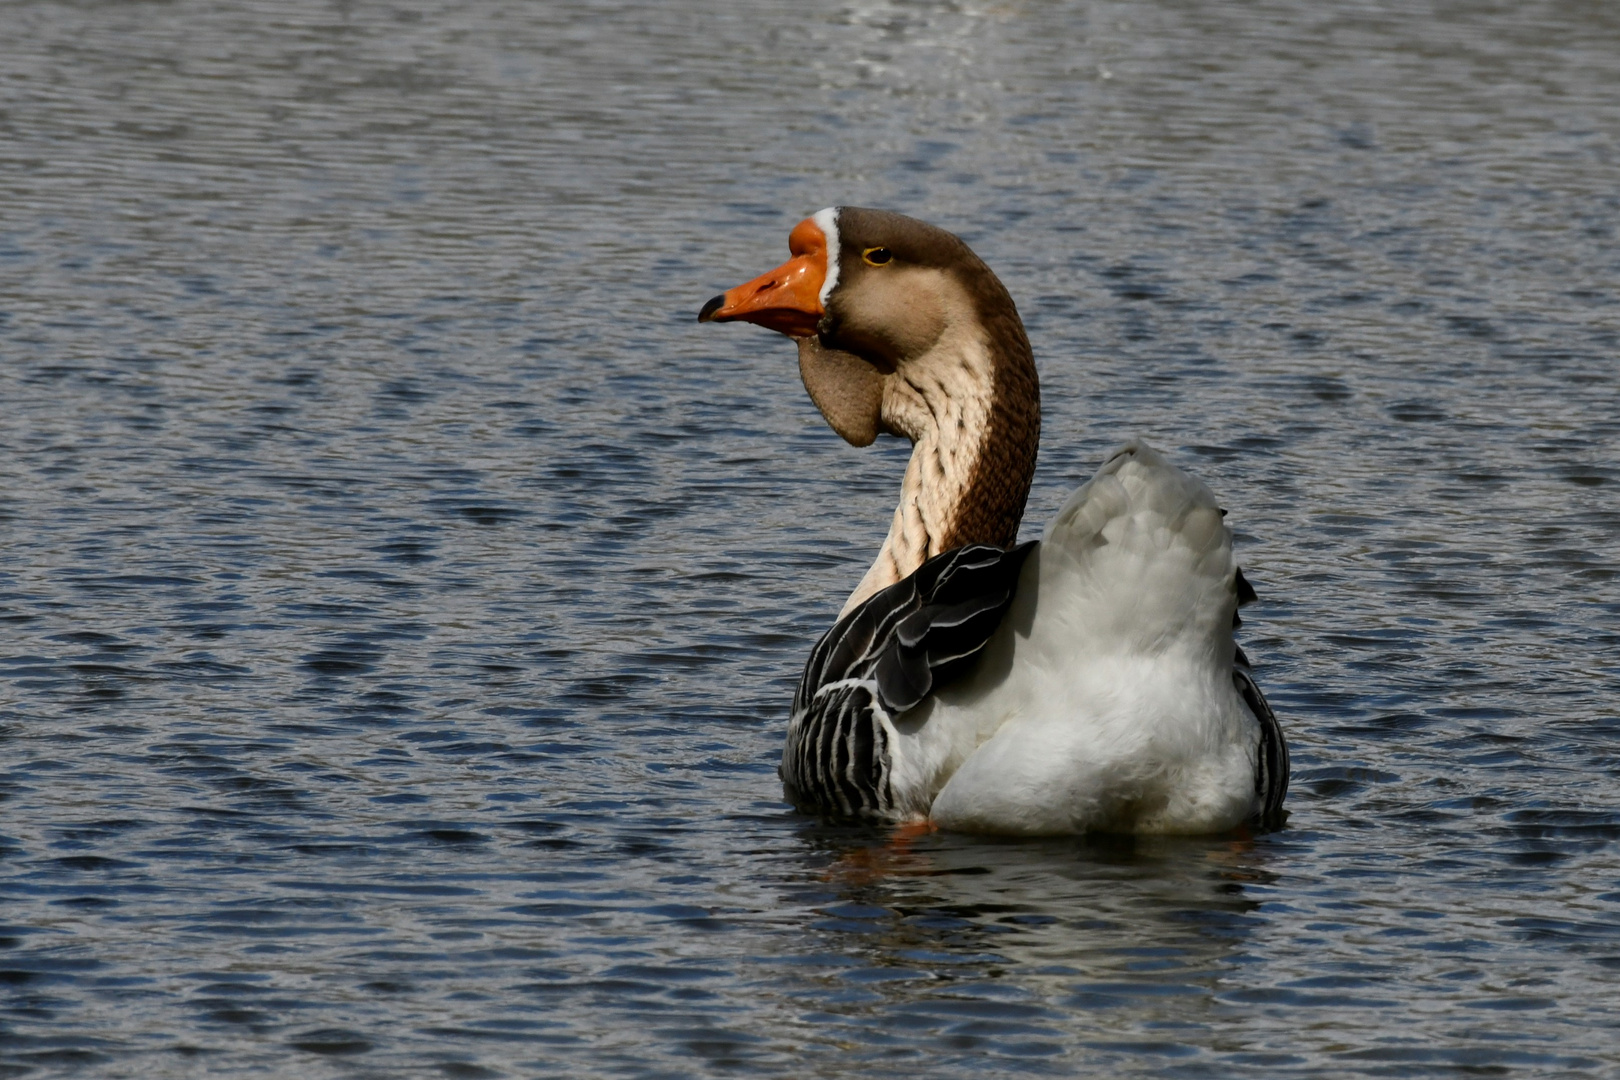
698,206,1288,836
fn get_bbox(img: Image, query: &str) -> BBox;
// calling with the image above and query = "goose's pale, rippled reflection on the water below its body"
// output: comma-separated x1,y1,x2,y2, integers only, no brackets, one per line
780,824,1277,1027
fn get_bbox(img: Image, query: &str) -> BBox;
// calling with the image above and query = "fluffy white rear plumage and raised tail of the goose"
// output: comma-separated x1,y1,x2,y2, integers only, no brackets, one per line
891,442,1260,834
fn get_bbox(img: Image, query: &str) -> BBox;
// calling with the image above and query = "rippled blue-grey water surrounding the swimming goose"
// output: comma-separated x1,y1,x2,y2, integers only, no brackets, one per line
0,0,1620,1077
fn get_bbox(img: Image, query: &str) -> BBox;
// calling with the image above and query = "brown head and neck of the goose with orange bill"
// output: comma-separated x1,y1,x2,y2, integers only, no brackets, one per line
698,206,1040,602
